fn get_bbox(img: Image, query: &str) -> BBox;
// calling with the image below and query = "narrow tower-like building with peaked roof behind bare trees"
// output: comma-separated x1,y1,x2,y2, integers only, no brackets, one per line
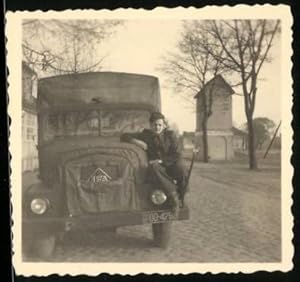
195,75,234,160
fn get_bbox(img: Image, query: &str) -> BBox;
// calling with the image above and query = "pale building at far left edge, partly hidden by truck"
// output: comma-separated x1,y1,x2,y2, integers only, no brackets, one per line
22,62,38,172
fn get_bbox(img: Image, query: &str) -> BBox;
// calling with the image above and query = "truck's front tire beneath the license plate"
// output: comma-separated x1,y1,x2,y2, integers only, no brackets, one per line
152,222,172,249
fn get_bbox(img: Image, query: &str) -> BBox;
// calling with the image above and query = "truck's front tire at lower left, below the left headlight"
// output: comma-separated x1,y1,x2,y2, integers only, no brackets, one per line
33,235,56,260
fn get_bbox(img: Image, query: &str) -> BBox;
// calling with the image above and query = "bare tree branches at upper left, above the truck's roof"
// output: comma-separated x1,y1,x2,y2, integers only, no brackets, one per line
22,19,122,74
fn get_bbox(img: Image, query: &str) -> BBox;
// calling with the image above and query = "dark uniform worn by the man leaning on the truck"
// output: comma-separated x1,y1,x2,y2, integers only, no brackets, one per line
121,129,186,198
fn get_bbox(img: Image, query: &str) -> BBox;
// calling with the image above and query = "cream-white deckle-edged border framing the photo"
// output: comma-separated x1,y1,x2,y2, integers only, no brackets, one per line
5,4,294,276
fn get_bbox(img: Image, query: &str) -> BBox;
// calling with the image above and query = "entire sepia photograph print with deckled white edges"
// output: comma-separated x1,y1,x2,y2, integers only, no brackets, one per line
6,6,293,274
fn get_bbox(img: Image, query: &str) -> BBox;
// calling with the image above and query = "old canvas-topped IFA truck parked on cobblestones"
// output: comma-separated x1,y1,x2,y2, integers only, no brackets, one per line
22,72,189,259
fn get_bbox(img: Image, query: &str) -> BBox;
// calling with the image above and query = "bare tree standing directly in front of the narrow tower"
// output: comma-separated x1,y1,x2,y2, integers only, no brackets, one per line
160,21,226,162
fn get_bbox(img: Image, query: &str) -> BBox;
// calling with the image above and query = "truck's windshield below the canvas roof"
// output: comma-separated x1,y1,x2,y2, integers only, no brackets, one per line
41,110,149,141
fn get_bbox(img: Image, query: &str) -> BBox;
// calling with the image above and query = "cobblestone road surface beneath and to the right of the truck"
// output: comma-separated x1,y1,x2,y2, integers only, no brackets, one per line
22,160,281,262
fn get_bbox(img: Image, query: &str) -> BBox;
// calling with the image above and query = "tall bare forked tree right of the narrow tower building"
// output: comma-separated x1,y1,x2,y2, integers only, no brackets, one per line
199,20,280,169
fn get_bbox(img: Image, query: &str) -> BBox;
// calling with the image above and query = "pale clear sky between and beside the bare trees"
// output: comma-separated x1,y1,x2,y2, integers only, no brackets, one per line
91,19,281,131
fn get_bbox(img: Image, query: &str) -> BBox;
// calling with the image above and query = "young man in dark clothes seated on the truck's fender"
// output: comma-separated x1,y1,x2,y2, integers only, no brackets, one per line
121,112,186,211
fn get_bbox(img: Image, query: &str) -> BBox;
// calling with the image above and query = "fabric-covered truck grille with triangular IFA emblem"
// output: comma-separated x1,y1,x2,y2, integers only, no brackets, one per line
65,155,138,215
